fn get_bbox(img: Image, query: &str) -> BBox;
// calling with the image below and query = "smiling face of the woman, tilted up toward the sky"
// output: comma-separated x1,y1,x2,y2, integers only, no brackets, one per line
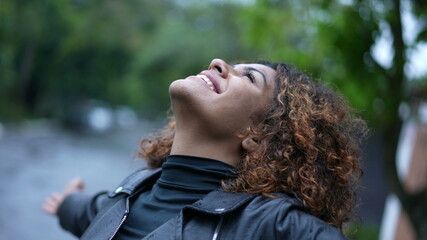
169,59,276,139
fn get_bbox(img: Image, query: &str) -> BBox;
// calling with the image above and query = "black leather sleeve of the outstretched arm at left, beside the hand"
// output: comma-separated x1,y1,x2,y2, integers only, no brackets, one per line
58,192,108,237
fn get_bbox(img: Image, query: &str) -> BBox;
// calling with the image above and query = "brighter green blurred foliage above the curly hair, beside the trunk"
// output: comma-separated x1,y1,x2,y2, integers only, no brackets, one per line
240,0,426,127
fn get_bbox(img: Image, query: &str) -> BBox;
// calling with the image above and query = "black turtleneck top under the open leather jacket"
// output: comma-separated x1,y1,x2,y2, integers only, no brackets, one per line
115,155,233,240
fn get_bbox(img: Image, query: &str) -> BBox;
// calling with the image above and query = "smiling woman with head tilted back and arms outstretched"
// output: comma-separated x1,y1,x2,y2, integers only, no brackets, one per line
44,59,366,239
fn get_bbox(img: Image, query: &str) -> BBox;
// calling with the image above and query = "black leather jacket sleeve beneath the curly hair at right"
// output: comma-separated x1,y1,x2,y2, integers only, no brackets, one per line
275,204,347,240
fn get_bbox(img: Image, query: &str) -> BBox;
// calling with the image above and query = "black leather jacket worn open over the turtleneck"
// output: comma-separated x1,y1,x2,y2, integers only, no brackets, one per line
58,169,346,240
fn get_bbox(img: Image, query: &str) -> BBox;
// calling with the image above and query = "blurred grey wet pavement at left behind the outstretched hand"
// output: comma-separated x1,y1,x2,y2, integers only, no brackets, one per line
0,121,160,240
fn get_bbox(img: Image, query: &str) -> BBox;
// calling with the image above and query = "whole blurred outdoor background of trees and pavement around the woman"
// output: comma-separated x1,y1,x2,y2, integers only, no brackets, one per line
0,0,427,239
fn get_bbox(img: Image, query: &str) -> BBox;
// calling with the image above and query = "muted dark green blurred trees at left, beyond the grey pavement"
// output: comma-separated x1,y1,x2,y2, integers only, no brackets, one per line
0,0,253,119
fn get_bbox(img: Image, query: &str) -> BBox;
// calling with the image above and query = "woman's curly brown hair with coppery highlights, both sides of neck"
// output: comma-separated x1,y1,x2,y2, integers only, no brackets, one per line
139,62,367,229
